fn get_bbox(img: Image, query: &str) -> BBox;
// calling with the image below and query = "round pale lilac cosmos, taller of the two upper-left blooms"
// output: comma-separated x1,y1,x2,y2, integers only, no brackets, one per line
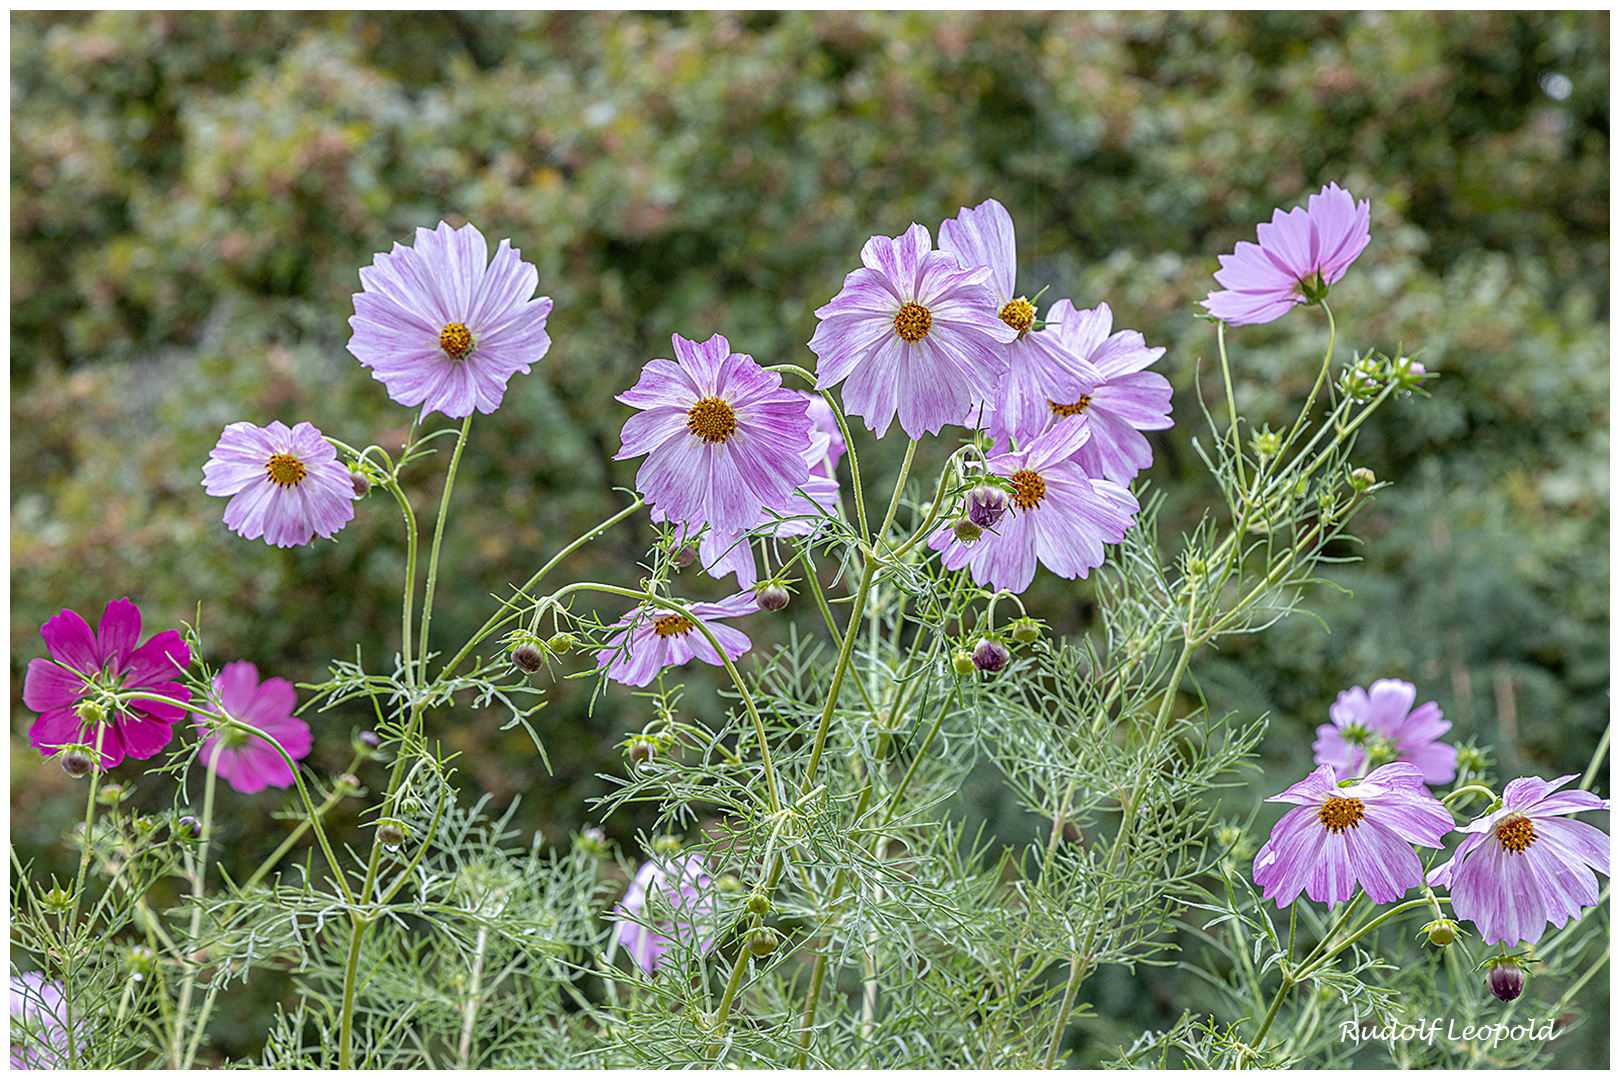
348,222,551,418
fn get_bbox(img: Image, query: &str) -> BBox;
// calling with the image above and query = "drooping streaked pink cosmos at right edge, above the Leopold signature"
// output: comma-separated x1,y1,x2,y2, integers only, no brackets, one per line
1429,772,1609,946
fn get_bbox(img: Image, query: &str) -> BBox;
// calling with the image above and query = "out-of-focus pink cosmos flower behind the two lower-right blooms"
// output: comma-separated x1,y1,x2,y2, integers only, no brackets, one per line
1311,678,1456,784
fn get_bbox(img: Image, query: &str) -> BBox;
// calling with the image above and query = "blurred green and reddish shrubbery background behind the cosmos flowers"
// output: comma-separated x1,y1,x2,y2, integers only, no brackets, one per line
11,11,1610,1065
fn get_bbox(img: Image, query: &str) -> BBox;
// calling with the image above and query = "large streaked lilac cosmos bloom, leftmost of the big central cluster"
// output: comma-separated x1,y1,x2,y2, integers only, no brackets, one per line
614,334,810,534
